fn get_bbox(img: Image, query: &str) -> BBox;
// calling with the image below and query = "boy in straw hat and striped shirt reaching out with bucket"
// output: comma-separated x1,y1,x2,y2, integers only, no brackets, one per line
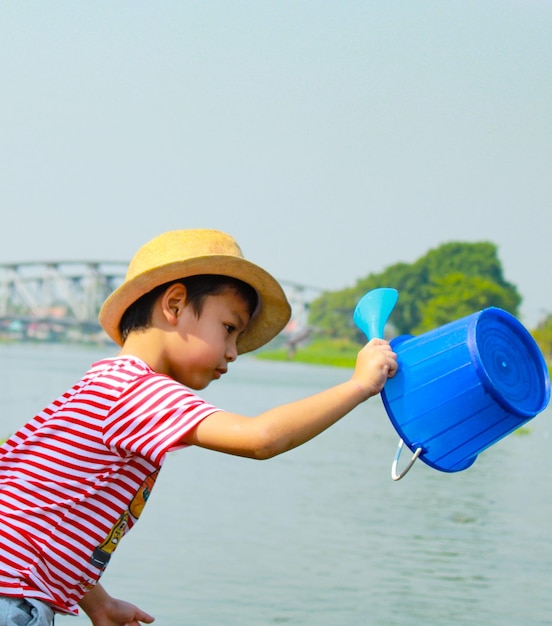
0,230,397,626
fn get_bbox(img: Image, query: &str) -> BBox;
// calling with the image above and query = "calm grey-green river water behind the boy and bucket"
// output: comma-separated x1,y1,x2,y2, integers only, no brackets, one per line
0,344,552,626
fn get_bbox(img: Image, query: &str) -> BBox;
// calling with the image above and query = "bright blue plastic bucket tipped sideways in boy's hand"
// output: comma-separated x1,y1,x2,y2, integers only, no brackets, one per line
382,307,550,472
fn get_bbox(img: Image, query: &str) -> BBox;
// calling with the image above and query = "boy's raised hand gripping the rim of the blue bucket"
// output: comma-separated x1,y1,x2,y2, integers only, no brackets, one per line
353,339,397,397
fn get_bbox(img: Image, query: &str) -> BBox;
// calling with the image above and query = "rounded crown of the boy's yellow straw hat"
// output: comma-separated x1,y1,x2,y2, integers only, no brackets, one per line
126,228,243,280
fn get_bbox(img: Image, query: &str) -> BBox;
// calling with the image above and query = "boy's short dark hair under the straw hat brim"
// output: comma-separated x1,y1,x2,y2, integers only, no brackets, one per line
119,274,259,343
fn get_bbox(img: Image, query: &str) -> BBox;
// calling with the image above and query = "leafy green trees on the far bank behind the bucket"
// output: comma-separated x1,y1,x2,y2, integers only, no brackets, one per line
309,241,552,360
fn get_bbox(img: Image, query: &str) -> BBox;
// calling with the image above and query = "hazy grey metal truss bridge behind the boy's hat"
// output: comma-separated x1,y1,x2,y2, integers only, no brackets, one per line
0,261,322,343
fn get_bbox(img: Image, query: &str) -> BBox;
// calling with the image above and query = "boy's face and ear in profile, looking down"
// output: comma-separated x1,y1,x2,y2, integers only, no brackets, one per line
166,289,250,389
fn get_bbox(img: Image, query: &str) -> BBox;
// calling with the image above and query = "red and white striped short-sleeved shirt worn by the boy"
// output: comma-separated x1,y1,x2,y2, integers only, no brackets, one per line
0,357,218,613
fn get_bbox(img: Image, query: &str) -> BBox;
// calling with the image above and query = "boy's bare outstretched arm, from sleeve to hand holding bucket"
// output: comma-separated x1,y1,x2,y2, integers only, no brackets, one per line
184,339,397,459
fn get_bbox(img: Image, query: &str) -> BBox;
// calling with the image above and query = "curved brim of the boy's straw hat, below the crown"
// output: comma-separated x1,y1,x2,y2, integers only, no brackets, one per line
99,255,291,354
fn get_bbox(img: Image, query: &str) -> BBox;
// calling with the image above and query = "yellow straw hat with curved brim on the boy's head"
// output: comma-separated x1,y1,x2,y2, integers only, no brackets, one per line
99,229,291,354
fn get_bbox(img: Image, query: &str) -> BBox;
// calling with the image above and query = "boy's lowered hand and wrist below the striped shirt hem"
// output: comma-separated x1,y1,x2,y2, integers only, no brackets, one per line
79,583,155,626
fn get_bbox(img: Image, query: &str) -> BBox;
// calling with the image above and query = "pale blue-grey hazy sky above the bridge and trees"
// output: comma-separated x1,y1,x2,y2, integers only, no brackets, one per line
0,0,552,327
